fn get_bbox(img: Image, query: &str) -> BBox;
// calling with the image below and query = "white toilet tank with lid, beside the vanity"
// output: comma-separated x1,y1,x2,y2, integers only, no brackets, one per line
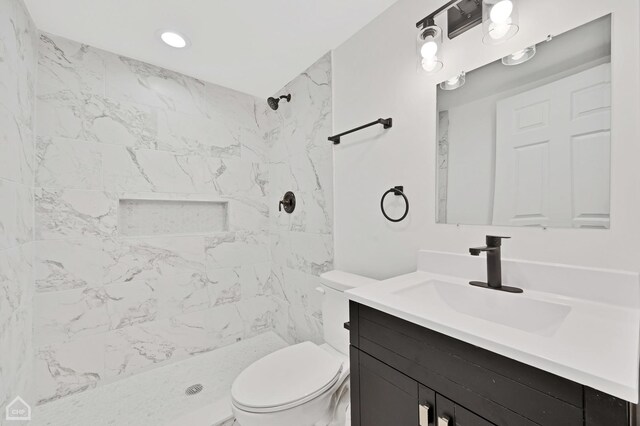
318,271,378,355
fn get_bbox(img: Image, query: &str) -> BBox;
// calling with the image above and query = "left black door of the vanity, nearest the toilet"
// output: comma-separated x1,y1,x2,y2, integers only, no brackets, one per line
354,352,427,426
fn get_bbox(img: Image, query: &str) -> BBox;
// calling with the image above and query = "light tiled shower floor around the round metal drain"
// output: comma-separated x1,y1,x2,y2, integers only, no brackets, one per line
30,332,287,426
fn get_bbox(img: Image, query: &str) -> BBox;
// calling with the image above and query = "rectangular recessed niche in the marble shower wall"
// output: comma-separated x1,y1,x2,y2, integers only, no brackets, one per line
118,198,229,237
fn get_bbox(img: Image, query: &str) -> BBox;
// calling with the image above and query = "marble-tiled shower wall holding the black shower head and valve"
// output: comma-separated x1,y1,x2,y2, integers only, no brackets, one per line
268,54,333,343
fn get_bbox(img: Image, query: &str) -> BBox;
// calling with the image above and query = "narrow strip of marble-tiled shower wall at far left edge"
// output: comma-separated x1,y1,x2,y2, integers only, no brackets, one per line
0,0,37,418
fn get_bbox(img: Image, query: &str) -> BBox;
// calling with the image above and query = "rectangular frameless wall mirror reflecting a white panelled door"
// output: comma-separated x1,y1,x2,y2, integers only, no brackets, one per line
436,16,611,229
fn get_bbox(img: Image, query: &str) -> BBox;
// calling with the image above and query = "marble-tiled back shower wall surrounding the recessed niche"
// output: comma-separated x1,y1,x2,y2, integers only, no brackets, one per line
34,34,278,403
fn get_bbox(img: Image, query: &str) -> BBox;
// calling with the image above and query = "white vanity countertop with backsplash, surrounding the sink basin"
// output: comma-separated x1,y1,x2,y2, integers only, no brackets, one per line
347,252,640,403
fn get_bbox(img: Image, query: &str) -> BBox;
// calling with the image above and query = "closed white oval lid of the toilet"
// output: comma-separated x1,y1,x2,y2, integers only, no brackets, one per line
231,342,342,412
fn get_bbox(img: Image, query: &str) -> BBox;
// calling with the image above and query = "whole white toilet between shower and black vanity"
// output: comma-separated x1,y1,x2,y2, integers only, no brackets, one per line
231,271,376,426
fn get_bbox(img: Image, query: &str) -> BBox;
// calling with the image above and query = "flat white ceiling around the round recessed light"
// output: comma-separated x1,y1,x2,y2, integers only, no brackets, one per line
25,0,396,97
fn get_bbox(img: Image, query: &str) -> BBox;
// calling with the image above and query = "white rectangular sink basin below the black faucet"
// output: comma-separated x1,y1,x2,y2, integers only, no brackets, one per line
393,280,571,336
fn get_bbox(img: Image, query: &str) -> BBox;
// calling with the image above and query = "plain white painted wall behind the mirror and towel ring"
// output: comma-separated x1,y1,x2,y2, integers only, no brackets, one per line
333,0,640,277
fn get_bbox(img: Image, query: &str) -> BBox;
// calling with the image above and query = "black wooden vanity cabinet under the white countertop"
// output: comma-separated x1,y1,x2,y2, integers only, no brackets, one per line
349,302,631,426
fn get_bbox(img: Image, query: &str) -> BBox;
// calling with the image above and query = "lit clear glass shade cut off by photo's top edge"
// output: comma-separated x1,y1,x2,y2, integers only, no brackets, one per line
482,0,520,44
